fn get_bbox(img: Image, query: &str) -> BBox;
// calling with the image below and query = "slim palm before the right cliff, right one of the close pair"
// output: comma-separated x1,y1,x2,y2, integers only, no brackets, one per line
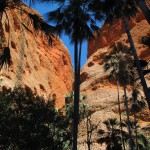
103,44,133,149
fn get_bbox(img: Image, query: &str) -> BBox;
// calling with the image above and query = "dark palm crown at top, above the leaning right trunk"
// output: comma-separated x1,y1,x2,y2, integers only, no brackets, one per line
91,0,138,23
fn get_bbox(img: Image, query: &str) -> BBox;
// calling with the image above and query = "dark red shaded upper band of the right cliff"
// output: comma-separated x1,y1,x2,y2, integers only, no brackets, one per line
88,0,150,58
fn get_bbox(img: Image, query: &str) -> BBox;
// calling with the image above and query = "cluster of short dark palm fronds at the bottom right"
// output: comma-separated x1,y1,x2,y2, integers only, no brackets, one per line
98,118,149,150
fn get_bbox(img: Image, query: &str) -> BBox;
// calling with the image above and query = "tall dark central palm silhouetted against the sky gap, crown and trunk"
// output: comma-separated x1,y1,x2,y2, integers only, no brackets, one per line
44,0,101,150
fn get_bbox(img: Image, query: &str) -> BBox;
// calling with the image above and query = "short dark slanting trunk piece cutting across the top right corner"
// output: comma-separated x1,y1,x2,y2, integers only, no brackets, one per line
136,0,150,24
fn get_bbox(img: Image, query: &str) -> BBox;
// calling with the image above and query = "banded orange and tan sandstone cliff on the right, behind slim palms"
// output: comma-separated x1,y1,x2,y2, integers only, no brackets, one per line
79,3,150,150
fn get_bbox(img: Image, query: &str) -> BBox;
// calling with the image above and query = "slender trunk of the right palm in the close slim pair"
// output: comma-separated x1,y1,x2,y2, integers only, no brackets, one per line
123,83,133,150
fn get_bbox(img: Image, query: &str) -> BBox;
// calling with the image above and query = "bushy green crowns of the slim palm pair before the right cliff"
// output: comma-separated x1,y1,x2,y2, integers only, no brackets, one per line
104,43,136,85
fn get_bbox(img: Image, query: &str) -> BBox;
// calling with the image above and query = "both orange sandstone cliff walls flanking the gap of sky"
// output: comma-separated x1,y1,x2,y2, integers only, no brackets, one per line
0,0,150,150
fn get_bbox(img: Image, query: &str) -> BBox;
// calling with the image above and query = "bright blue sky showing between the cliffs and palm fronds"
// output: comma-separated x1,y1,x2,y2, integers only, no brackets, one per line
25,3,87,66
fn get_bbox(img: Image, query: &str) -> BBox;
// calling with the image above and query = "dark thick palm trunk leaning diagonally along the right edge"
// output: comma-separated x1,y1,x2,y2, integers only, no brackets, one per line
121,12,150,109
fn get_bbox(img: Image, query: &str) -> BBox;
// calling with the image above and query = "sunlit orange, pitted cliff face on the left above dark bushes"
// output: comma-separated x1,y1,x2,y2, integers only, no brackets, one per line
0,4,73,107
